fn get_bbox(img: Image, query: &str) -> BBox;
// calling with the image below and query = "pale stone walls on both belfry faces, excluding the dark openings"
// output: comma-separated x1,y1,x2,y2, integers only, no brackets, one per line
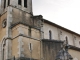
0,0,32,14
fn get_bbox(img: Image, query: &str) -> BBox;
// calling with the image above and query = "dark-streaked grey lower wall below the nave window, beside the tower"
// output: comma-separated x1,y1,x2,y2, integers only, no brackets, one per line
42,39,63,60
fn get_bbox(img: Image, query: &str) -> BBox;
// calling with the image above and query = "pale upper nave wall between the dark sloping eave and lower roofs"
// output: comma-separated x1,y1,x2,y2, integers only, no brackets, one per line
43,23,80,47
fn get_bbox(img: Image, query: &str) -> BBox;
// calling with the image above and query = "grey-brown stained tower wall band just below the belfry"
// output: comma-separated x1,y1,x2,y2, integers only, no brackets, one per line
12,7,41,29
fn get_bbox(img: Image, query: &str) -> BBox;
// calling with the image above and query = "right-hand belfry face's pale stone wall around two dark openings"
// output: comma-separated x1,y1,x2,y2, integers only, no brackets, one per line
10,0,32,13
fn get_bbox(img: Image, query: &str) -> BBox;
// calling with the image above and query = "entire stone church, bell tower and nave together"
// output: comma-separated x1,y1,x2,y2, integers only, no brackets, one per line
0,0,80,60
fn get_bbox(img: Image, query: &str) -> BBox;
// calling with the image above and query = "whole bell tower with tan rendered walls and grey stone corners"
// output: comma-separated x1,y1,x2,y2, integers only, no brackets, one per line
0,0,43,60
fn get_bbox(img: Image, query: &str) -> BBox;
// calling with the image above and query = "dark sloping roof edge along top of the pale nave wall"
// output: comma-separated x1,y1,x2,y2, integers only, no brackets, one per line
43,19,80,36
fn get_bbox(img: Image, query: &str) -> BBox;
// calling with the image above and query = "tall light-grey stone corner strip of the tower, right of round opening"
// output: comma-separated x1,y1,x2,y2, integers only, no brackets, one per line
6,7,13,59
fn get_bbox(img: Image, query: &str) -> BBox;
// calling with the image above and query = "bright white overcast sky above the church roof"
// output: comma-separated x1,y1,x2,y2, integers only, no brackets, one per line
33,0,80,34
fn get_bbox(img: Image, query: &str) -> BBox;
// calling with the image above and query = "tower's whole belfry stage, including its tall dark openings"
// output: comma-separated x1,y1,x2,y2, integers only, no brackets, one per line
0,0,32,14
